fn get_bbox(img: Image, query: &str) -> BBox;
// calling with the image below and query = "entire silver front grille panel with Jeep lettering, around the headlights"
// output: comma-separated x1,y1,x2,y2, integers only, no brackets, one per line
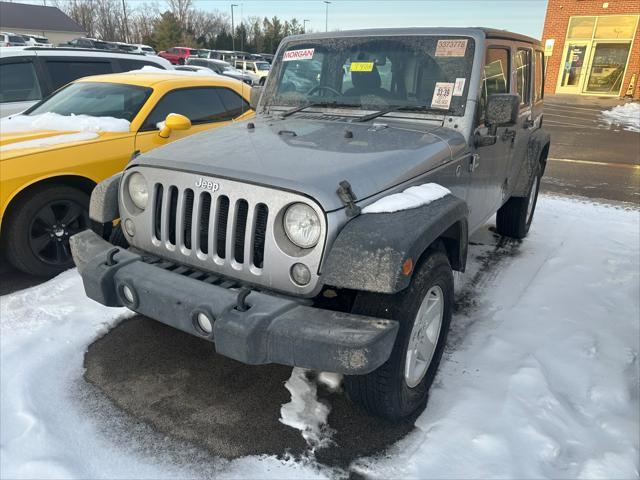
120,165,327,295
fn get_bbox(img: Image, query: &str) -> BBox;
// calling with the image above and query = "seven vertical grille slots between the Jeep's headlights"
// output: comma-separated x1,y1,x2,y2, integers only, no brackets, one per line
152,183,269,268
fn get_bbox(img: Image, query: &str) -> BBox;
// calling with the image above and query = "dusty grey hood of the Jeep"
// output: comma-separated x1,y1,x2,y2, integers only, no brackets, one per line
131,115,466,211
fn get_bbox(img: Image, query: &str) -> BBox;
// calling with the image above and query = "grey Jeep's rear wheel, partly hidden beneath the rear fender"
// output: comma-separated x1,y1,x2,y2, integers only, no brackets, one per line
496,165,541,240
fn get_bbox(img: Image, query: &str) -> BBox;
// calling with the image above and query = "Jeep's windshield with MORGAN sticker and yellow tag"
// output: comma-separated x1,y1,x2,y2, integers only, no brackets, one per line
265,35,475,115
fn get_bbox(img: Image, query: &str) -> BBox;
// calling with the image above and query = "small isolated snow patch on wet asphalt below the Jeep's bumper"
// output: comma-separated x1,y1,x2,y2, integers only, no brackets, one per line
280,368,332,451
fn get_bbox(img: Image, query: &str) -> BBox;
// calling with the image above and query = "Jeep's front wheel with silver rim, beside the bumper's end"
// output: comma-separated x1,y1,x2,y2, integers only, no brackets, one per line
345,250,453,420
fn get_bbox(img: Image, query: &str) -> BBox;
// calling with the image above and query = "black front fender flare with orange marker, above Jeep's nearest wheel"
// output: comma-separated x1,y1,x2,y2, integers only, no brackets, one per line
322,195,469,293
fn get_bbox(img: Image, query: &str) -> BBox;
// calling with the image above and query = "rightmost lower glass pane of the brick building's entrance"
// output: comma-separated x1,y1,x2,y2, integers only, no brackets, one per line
585,42,631,95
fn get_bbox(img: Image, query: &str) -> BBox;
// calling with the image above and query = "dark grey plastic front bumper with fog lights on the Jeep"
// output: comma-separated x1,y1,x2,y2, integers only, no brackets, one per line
71,231,398,375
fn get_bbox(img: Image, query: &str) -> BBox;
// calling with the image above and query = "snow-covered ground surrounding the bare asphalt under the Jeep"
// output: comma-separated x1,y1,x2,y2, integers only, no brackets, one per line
0,197,640,479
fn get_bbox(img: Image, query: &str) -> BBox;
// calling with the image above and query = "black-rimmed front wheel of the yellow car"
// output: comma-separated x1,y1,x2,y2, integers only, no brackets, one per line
4,185,91,277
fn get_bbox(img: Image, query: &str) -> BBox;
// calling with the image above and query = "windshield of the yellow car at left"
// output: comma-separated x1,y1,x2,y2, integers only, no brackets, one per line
26,82,151,121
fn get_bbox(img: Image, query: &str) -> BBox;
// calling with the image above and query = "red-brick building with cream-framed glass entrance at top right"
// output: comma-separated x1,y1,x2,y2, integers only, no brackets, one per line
542,0,640,98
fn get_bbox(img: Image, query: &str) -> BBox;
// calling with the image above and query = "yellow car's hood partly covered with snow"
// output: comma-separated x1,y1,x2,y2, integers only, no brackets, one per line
0,130,113,160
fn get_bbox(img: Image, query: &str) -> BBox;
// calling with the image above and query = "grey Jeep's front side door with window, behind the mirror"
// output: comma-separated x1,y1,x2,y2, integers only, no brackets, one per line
467,42,512,232
